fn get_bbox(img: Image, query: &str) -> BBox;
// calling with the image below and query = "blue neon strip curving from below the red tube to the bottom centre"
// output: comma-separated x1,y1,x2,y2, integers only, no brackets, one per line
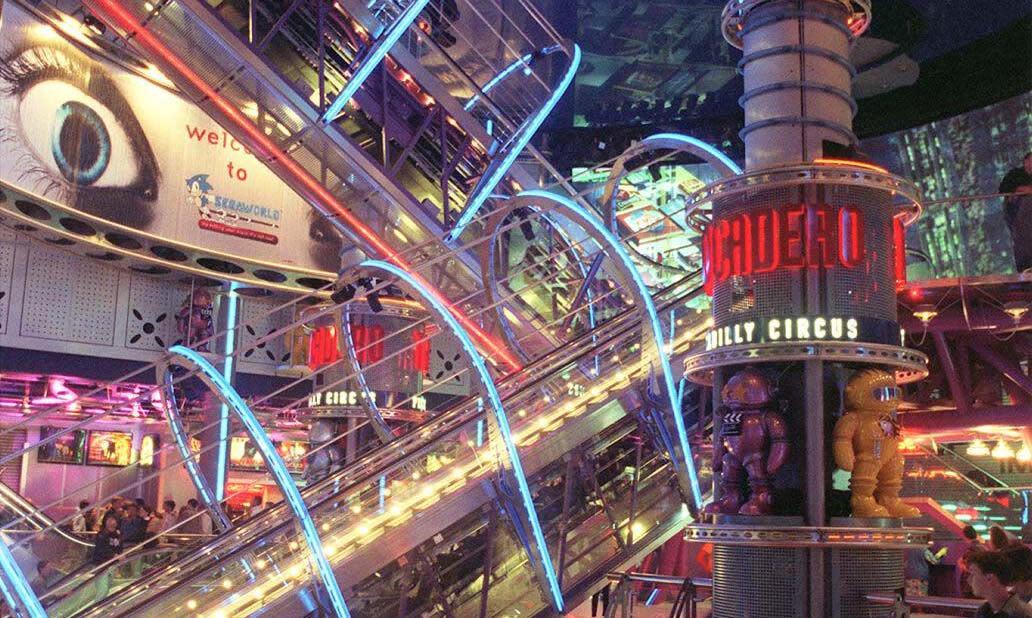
359,260,563,613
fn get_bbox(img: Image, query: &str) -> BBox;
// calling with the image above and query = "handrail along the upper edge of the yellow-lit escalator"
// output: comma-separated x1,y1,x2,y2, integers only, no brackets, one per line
78,278,703,611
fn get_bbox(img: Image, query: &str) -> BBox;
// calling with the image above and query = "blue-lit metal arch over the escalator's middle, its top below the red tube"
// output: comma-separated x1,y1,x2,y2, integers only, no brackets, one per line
358,260,563,613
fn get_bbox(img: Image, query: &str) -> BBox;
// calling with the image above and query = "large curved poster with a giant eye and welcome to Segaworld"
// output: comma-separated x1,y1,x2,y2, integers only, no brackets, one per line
0,3,340,270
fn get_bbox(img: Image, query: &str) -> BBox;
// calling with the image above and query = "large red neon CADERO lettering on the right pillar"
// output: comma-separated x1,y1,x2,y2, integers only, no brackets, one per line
702,204,864,294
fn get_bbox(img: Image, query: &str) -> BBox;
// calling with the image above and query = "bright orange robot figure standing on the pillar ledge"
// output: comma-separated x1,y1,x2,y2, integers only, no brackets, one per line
833,369,920,517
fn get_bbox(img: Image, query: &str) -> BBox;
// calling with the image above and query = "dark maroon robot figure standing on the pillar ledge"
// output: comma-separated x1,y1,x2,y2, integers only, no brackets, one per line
704,369,788,515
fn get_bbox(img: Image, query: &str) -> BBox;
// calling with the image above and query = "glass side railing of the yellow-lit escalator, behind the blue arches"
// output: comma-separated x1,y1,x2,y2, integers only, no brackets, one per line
64,276,698,616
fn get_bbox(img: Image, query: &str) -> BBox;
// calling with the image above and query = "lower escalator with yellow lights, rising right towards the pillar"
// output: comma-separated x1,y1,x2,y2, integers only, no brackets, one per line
54,277,704,617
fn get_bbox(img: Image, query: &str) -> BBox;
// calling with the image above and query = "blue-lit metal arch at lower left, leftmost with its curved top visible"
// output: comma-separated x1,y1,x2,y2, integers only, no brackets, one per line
160,346,351,618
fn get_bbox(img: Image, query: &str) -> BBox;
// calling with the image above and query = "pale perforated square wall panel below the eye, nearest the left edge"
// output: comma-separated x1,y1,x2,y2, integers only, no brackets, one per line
21,245,119,346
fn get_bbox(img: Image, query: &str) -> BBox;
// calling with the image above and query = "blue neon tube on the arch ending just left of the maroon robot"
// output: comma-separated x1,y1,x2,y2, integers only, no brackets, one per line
516,190,703,507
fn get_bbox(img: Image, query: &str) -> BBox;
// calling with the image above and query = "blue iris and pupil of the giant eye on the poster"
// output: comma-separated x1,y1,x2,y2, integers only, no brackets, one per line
51,101,111,185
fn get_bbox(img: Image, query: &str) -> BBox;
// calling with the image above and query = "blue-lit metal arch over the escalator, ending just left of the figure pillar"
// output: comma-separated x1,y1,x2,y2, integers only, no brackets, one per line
495,190,703,509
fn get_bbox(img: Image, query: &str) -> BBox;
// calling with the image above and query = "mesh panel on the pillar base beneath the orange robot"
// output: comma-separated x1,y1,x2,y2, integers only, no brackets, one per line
832,548,903,618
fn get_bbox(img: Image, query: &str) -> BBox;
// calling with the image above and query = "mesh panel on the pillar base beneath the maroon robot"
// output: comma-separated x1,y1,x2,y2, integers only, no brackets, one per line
713,545,808,618
